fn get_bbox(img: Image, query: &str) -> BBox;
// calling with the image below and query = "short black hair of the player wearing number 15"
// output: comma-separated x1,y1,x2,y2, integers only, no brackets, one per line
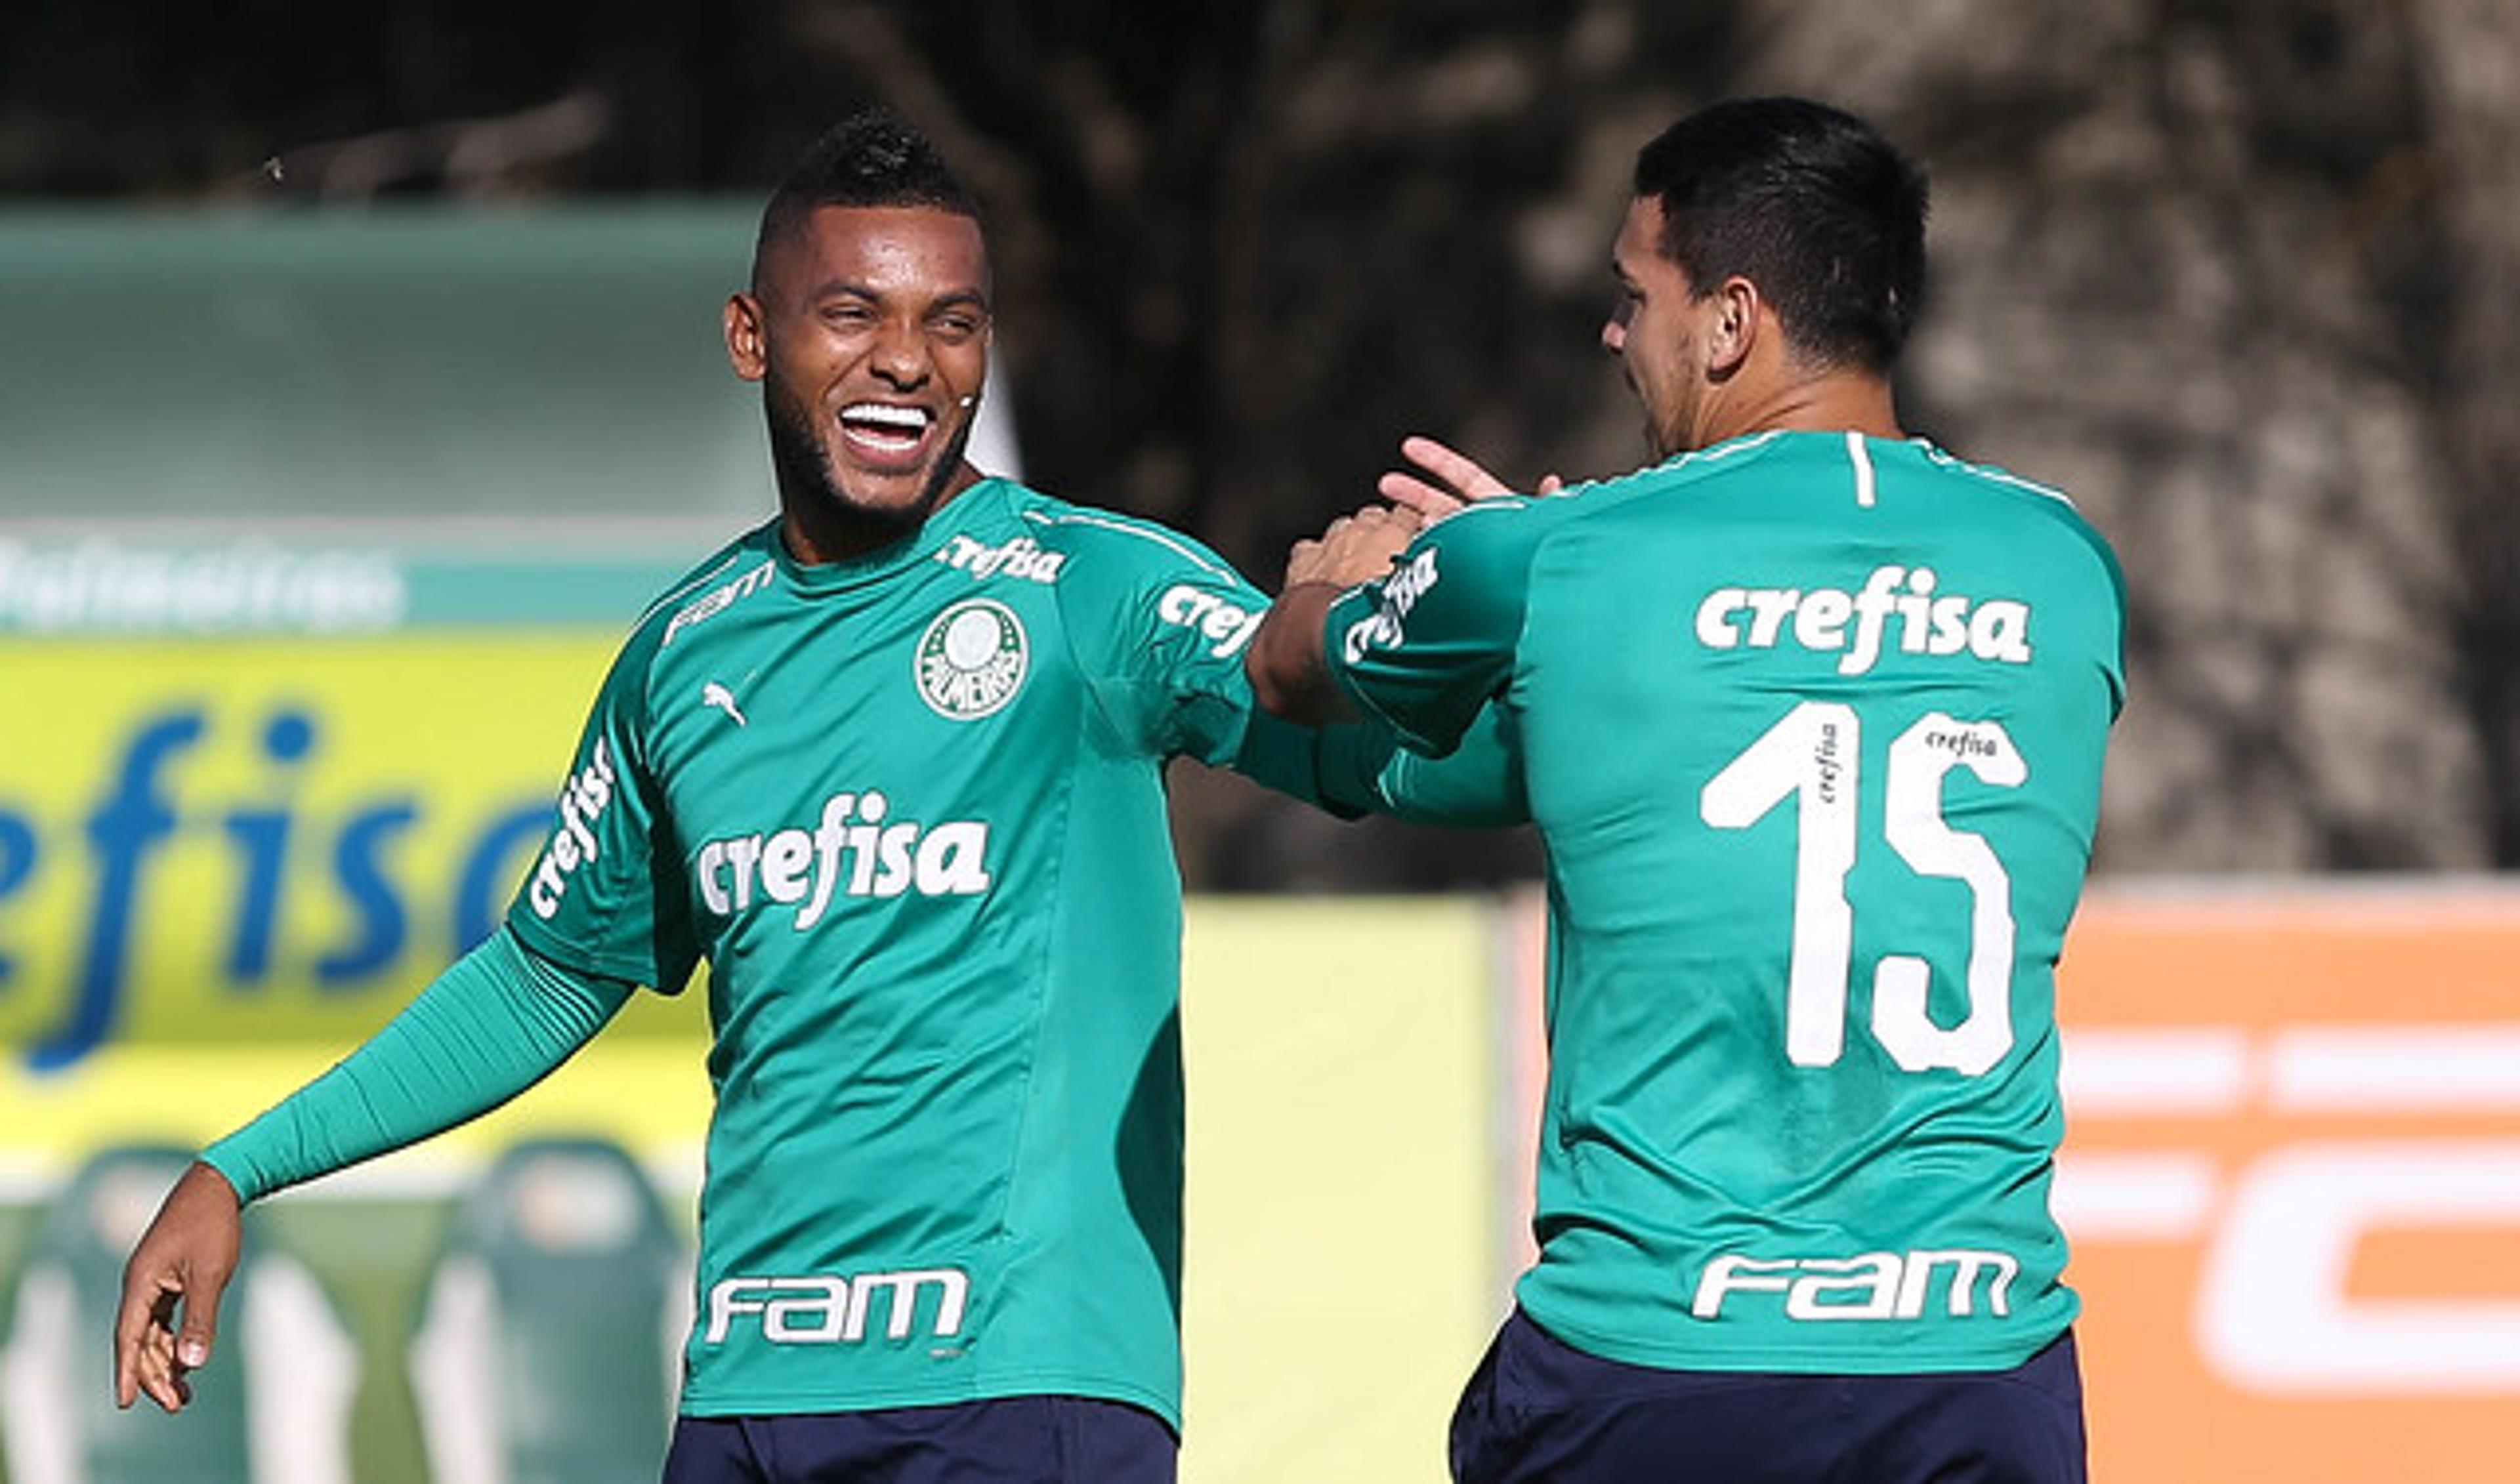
1635,98,1925,371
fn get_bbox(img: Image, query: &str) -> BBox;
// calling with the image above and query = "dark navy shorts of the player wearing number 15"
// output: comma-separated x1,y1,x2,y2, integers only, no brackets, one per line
1452,1310,2084,1484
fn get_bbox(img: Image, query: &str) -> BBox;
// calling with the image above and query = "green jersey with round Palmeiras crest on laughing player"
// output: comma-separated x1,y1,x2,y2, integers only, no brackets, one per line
509,482,1311,1424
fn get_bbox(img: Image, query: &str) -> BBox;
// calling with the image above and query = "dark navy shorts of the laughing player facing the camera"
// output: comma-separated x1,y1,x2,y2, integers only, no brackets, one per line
665,1396,1179,1484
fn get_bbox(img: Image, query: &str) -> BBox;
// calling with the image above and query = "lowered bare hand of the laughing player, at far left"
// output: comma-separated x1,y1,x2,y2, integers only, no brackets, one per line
114,1161,244,1411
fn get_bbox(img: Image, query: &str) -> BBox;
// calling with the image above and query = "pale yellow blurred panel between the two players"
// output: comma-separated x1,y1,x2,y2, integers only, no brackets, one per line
1182,899,1504,1484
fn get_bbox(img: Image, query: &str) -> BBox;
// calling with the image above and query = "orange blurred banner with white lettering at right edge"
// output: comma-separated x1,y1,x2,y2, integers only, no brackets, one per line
2056,884,2520,1484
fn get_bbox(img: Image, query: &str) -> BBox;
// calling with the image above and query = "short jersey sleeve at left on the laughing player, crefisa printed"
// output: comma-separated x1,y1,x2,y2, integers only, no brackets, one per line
507,630,701,995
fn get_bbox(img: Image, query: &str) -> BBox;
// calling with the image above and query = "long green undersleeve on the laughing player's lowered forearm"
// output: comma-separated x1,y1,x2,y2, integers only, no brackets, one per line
201,927,638,1202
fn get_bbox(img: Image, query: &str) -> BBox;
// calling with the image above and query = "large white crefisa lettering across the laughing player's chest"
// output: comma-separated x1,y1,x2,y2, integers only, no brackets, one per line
693,789,990,932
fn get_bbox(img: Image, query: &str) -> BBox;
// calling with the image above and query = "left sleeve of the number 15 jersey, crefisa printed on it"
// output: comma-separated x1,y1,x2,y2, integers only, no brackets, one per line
1320,499,1540,756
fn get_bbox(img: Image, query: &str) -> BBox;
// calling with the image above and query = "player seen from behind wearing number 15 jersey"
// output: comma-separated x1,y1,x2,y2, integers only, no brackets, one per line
1250,98,2124,1484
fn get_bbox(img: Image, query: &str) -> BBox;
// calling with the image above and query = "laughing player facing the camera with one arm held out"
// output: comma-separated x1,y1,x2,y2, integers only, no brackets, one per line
116,116,1461,1484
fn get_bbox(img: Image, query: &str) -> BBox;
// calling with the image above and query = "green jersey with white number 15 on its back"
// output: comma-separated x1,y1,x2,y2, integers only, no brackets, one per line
1326,434,2124,1373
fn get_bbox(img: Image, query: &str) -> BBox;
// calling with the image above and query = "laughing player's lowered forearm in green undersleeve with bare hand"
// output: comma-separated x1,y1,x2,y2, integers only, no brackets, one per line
114,930,638,1411
